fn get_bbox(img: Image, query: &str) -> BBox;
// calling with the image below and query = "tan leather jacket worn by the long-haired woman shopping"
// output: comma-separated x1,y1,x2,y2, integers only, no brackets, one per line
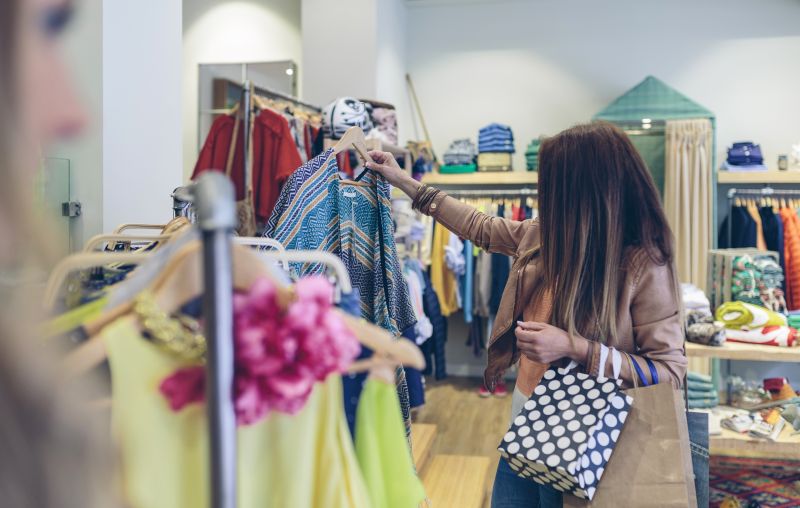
414,187,687,389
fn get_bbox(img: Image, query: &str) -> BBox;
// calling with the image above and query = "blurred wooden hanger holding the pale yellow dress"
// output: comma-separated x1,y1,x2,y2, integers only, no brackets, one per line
64,241,425,375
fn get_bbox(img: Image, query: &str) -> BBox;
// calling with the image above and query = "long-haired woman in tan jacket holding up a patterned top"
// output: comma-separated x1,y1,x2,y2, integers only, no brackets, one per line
368,122,686,508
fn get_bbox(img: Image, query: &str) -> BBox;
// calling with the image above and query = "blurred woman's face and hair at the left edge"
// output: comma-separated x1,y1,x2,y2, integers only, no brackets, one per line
0,0,117,508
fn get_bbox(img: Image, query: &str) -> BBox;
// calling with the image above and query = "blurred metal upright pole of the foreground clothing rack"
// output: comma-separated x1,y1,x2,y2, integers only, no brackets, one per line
193,171,237,508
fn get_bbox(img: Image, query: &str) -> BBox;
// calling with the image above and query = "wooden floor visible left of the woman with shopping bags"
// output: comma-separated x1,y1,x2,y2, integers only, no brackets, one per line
414,377,511,508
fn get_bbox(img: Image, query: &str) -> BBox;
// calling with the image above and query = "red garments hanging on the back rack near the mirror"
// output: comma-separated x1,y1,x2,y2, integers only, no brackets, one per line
192,109,302,222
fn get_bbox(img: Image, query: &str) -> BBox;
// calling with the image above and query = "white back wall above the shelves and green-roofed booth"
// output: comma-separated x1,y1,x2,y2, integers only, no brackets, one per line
408,0,800,169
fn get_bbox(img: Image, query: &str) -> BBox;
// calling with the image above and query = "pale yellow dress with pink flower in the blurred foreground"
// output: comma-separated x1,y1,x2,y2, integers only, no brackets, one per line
103,318,370,508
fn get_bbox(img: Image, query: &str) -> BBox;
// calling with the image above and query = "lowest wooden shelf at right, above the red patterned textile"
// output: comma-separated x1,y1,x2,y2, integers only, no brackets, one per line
709,423,800,459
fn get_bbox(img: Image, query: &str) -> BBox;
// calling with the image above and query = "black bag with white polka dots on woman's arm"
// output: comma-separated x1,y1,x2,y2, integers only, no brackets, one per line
498,362,633,499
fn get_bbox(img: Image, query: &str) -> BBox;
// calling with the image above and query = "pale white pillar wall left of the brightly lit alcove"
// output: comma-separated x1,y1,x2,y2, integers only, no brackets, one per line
103,0,183,231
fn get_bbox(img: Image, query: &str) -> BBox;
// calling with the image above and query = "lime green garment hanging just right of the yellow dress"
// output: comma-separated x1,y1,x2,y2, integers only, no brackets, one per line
355,379,425,508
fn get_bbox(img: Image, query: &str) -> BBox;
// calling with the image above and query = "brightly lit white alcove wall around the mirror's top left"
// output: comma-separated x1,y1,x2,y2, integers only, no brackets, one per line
181,0,303,179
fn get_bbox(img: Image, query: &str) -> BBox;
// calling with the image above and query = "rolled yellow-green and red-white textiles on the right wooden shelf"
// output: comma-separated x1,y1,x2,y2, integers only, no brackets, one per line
716,302,797,347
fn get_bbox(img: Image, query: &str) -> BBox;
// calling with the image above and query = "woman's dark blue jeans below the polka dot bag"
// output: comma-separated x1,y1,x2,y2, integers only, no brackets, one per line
492,458,563,508
